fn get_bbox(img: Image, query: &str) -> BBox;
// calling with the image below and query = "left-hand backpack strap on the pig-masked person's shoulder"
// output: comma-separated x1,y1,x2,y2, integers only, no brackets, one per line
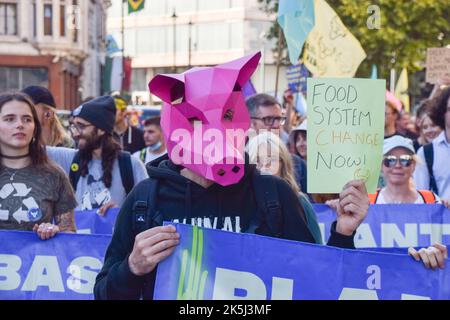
131,178,163,235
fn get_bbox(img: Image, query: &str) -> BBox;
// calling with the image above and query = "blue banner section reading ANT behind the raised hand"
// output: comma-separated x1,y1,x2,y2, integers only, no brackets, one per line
313,204,450,248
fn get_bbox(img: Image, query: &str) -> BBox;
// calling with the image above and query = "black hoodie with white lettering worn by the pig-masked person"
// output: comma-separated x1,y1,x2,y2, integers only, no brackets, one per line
94,160,354,299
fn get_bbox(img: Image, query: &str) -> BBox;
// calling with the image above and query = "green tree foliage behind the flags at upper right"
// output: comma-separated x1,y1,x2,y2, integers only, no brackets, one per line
258,0,450,78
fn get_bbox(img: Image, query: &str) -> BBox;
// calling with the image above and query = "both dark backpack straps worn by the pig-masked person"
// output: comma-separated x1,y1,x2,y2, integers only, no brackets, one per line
132,162,312,242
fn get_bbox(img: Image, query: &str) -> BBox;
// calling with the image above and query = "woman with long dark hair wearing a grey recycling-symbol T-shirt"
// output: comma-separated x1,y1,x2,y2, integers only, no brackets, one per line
0,93,76,240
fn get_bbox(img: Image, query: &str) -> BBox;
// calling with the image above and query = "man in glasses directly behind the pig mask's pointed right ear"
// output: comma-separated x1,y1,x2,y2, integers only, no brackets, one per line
245,93,307,193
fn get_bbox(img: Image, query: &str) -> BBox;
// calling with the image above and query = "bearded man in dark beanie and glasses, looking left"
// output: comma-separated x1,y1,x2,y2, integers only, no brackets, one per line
48,96,148,215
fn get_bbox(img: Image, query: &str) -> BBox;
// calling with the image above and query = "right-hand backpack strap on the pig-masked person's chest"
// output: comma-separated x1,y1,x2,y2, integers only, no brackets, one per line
247,170,283,238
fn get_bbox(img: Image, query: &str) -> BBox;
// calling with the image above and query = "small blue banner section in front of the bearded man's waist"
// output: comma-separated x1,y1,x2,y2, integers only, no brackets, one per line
75,208,119,235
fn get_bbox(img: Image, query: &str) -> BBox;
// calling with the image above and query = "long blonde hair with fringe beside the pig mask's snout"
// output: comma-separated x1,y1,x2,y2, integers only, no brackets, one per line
247,130,300,193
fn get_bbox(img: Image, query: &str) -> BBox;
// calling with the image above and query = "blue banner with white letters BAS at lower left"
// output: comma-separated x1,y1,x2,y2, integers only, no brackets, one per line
0,231,111,300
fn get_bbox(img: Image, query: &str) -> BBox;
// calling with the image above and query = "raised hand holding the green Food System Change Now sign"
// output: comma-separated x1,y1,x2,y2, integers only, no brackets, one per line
336,179,369,236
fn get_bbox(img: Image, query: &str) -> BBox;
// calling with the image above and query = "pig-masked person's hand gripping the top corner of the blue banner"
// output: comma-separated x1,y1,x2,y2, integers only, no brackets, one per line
128,225,180,276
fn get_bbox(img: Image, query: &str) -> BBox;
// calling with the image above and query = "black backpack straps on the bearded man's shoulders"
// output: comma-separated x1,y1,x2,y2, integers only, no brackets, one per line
69,151,134,195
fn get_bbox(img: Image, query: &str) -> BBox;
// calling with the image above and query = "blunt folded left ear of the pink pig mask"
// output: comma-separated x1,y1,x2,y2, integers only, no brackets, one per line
148,74,184,104
